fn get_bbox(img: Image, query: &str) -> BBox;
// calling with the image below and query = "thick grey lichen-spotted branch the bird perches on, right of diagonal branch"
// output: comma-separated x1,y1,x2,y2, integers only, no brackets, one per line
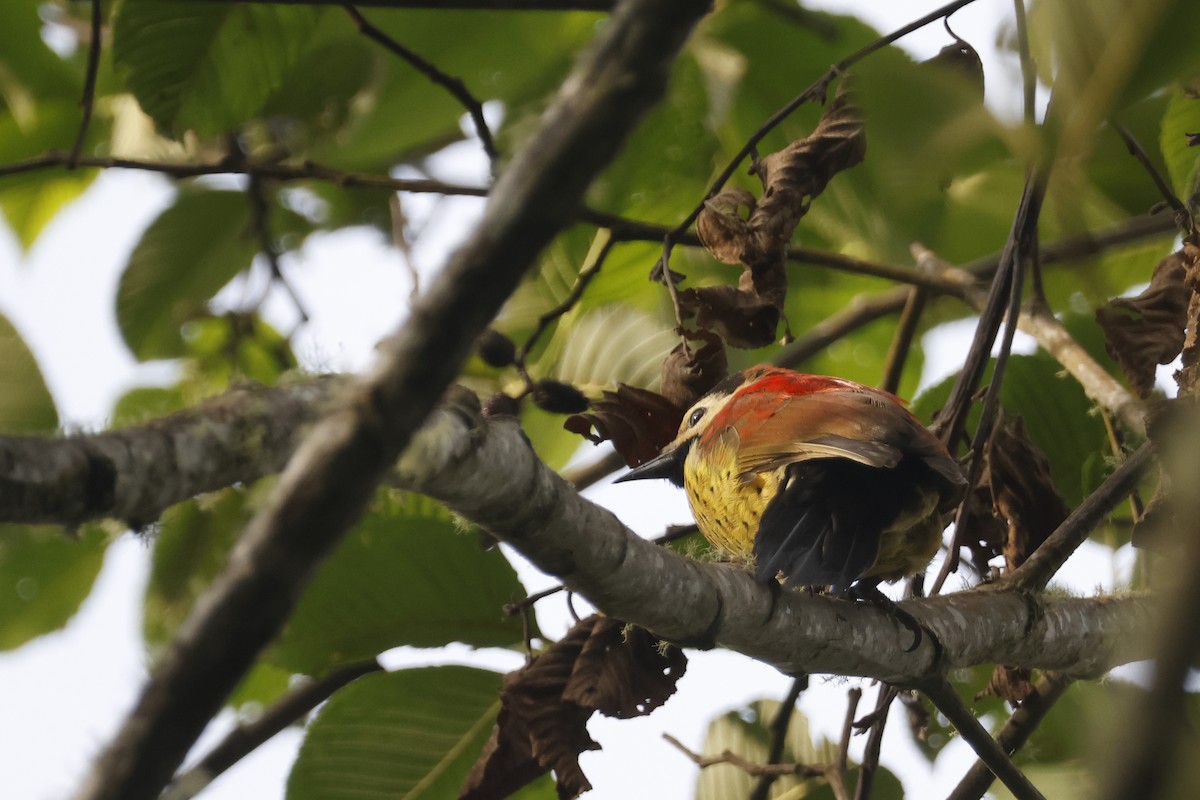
398,402,1153,685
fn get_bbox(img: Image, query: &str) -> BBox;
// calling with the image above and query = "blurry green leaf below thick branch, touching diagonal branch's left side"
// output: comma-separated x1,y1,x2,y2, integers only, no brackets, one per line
142,488,250,649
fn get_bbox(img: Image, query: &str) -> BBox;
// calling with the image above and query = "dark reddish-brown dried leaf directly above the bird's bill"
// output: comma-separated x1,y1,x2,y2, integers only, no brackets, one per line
563,384,684,467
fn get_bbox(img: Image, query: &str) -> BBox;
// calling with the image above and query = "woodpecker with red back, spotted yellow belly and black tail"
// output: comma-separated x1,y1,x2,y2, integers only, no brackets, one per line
620,366,966,591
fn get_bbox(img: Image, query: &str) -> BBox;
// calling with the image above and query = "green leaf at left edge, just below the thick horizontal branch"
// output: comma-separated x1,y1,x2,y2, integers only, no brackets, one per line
0,524,108,650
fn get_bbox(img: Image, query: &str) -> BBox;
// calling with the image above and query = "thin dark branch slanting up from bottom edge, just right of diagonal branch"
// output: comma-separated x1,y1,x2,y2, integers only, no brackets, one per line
163,658,383,800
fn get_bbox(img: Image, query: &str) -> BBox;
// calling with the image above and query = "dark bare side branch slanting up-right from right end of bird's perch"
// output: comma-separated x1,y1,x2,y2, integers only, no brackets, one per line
1003,441,1154,591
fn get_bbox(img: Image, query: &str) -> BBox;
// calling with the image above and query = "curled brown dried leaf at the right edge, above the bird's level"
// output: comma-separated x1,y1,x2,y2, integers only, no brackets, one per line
1096,246,1200,397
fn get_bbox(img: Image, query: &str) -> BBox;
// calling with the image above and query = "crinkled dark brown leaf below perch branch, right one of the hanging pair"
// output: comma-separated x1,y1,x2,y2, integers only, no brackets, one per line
563,618,688,720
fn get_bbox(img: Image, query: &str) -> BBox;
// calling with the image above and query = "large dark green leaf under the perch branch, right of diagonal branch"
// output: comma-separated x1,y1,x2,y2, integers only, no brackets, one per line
266,495,535,675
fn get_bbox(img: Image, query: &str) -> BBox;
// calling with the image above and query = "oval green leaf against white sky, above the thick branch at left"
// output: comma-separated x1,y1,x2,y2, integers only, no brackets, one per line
116,190,258,361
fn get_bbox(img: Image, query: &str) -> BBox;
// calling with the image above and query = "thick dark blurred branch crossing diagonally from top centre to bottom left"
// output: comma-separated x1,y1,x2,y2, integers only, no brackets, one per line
72,0,708,800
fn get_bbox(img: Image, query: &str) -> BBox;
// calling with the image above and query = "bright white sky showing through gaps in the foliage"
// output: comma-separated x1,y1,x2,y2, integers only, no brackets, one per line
0,0,1124,800
